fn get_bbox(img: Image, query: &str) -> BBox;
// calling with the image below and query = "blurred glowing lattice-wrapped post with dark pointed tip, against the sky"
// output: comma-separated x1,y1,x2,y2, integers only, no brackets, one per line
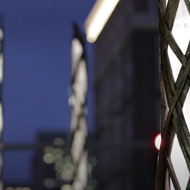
69,24,88,190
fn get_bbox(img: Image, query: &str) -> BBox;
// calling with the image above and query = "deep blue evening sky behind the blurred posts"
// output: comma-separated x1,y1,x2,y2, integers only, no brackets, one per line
0,0,95,181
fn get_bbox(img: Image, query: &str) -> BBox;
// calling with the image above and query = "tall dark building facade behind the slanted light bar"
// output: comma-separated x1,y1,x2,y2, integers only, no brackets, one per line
91,0,160,190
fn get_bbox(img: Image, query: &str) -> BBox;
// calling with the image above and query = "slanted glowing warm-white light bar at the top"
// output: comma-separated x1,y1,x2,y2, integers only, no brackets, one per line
85,0,119,43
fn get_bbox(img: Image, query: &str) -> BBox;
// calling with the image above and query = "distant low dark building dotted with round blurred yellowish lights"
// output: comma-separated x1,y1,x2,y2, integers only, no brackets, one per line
31,131,97,190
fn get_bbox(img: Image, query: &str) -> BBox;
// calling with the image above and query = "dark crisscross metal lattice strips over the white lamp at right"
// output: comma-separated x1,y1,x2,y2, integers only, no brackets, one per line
156,0,190,190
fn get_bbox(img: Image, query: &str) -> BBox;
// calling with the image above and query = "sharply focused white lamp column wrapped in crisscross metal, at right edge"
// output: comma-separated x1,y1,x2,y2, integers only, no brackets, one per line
156,0,190,190
